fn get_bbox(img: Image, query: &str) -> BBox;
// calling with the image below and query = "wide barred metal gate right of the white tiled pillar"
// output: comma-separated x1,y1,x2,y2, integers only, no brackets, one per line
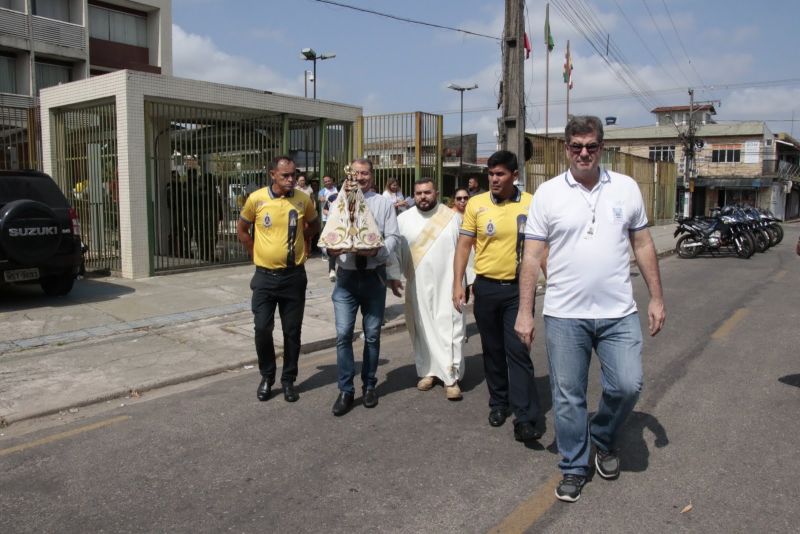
145,101,352,274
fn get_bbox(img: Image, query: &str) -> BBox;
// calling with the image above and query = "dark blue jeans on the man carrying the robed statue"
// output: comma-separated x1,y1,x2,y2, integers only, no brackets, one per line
331,267,386,393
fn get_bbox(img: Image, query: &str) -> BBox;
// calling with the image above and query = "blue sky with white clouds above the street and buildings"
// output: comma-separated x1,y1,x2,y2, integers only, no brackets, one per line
172,0,800,156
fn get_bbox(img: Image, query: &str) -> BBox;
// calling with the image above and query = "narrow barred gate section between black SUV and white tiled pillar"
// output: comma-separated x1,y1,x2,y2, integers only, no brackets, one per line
51,101,121,272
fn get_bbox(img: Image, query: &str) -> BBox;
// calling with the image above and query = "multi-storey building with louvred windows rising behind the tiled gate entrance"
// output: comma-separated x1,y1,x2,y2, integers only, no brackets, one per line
0,0,172,105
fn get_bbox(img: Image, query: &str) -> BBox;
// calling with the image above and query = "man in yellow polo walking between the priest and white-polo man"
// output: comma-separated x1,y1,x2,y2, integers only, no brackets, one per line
453,150,542,442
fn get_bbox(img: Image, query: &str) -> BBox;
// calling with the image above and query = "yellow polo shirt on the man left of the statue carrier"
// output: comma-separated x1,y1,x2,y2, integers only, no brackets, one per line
239,187,317,269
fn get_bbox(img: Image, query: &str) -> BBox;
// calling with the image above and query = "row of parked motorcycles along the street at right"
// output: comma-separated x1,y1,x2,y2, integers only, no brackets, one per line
675,206,783,258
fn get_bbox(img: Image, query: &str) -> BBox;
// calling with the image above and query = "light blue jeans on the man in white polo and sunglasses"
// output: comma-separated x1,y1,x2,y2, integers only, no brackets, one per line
544,313,642,476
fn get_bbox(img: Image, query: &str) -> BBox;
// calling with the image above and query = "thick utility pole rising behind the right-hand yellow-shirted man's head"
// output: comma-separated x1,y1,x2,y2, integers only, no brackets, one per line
497,0,527,189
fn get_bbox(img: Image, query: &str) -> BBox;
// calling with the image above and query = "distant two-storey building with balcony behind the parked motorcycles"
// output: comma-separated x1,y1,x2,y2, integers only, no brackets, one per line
605,105,800,218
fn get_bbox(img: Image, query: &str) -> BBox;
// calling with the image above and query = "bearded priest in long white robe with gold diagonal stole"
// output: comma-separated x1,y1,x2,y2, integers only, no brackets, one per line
387,178,472,400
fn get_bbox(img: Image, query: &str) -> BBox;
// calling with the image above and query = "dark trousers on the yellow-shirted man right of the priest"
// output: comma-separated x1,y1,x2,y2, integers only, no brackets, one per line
472,277,540,424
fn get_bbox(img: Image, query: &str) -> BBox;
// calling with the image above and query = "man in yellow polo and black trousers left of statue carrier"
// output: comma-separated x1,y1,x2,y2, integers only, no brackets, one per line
236,156,319,402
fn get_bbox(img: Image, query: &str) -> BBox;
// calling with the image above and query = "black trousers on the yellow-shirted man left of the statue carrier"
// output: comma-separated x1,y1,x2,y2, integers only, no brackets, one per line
250,265,308,383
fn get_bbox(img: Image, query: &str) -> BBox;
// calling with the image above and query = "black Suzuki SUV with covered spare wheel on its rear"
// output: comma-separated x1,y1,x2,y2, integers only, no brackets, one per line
0,171,83,296
